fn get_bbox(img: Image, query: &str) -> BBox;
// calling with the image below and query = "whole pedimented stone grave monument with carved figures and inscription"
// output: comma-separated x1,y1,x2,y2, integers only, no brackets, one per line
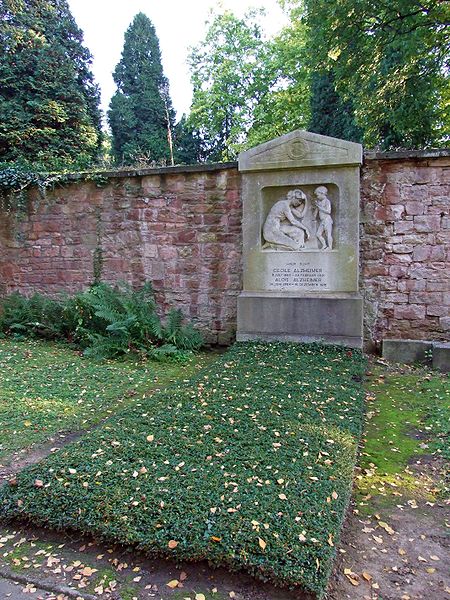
237,131,363,347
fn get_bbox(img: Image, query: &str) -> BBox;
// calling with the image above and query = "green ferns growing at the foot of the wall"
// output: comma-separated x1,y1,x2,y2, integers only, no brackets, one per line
0,283,202,359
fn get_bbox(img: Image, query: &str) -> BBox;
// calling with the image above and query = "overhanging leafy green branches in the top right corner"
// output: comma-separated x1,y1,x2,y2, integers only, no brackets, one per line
283,0,450,149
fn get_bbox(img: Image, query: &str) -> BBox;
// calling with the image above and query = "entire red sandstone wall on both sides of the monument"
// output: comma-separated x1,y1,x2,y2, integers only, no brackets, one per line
0,155,450,343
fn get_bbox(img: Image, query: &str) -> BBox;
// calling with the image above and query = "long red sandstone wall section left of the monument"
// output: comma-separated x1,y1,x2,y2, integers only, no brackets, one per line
0,166,242,343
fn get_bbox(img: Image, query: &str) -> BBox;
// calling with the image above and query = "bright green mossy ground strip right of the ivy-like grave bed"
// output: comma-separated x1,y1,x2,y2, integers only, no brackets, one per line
355,361,450,513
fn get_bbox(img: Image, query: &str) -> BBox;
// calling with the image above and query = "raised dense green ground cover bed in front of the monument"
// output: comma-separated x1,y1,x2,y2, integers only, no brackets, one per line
0,343,365,597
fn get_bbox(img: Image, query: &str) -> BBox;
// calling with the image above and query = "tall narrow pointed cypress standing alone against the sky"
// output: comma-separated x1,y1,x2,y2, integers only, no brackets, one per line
108,13,174,162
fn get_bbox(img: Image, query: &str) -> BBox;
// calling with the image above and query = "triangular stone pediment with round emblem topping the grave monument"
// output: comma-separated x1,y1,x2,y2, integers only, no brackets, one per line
239,130,362,171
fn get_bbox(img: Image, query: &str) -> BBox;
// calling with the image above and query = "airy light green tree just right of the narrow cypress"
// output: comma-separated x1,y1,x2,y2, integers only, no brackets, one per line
188,11,271,161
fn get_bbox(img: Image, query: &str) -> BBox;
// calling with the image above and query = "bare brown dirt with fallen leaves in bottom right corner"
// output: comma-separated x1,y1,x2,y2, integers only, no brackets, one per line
327,472,450,600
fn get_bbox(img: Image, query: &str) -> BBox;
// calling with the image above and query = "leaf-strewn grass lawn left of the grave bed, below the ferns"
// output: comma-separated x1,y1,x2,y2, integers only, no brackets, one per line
0,339,215,462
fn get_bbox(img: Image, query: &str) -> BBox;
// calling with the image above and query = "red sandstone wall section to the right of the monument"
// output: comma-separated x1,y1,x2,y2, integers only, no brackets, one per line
361,156,450,340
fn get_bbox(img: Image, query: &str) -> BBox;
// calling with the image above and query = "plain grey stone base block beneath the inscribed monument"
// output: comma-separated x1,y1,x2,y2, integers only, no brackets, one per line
236,292,363,348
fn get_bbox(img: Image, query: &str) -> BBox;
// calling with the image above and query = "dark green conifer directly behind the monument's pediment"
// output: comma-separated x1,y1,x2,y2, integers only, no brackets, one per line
308,71,362,142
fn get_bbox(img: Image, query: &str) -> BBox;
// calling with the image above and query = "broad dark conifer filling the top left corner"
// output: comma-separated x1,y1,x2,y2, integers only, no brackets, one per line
0,0,102,169
